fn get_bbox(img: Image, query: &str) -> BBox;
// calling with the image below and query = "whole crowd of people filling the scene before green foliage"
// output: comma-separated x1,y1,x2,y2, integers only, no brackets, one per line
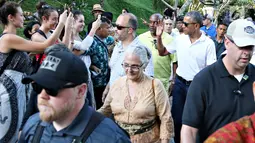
0,0,255,143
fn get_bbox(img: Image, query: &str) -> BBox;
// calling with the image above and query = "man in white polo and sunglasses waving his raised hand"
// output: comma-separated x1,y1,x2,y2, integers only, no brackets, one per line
154,11,216,143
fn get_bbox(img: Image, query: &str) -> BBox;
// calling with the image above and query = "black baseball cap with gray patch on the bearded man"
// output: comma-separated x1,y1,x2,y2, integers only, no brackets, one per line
22,45,88,90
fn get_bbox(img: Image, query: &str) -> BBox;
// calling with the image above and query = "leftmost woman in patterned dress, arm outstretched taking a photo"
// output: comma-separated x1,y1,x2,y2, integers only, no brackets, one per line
0,1,67,143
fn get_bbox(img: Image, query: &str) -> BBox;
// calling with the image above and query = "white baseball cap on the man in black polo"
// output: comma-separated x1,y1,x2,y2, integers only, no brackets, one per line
226,19,255,47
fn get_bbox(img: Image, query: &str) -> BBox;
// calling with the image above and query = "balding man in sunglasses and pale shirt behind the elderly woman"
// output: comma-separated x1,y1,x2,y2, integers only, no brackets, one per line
102,13,154,101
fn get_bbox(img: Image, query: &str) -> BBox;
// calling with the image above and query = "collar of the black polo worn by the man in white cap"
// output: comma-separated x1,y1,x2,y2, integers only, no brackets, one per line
216,56,254,80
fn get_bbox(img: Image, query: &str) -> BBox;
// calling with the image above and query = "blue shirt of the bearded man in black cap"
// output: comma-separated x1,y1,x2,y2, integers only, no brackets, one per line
19,104,131,143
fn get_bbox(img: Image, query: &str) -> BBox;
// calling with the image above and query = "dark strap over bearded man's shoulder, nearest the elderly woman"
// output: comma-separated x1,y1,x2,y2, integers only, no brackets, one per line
73,111,105,143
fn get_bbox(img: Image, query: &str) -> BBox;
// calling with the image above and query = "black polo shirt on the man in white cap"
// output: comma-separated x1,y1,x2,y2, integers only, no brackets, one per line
182,59,255,142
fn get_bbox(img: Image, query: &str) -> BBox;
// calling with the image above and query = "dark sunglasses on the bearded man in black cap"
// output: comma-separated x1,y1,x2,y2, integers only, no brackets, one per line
32,82,77,97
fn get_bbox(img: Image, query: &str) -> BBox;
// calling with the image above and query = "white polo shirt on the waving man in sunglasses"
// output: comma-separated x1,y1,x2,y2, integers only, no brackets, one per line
166,34,216,81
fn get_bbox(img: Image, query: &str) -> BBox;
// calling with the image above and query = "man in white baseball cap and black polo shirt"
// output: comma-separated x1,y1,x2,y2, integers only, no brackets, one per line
181,19,255,143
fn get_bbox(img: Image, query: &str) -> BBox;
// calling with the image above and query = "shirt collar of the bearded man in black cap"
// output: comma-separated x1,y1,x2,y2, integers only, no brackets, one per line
49,103,92,137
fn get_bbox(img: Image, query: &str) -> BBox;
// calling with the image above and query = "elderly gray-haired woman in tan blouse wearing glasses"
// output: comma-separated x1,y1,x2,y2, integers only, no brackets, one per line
98,47,174,143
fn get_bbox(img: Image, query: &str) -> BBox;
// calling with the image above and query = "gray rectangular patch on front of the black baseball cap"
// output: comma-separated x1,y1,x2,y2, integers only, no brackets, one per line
40,55,61,72
